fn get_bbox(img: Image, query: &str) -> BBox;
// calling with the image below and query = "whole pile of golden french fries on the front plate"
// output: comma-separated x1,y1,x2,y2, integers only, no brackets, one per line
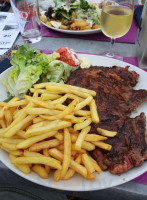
0,82,116,181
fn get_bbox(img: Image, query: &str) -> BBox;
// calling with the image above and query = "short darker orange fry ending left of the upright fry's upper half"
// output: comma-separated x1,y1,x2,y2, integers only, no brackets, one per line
29,139,61,151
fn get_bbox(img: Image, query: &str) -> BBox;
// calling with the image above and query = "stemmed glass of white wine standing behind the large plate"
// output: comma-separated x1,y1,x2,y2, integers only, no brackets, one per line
101,0,134,57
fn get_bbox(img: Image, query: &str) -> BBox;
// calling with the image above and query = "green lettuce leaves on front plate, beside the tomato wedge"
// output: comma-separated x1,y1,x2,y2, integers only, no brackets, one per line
3,44,76,97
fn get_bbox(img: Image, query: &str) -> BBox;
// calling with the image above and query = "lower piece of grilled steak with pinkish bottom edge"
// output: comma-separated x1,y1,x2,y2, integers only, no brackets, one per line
91,113,147,174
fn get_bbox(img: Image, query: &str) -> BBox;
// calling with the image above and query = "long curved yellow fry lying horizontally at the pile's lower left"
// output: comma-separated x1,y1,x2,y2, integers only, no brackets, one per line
12,156,62,169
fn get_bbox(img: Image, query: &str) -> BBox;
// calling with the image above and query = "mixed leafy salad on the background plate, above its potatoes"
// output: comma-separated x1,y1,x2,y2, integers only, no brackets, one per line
45,0,101,26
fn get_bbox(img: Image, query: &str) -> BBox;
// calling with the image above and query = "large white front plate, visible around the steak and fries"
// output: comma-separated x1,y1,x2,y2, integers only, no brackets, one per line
0,54,147,191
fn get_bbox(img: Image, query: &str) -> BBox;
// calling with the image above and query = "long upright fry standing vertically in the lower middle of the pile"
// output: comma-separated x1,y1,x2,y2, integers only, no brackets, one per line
61,128,71,177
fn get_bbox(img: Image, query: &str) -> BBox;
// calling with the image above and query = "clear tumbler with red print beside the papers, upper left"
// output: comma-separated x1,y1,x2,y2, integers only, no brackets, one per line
10,0,41,43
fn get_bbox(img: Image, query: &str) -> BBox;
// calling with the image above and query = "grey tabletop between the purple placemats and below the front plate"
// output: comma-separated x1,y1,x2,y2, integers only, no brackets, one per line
0,31,147,200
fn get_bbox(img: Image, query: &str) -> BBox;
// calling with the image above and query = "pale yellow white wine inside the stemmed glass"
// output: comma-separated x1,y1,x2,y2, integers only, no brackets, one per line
101,5,133,38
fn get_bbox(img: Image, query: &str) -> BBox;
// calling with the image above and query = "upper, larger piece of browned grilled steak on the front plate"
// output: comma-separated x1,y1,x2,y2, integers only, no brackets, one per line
67,66,147,121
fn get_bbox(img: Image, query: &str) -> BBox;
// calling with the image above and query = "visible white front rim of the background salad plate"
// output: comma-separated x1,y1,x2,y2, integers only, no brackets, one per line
41,21,101,35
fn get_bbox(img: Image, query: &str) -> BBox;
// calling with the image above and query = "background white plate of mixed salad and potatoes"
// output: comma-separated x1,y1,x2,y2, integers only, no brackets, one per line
40,0,102,35
